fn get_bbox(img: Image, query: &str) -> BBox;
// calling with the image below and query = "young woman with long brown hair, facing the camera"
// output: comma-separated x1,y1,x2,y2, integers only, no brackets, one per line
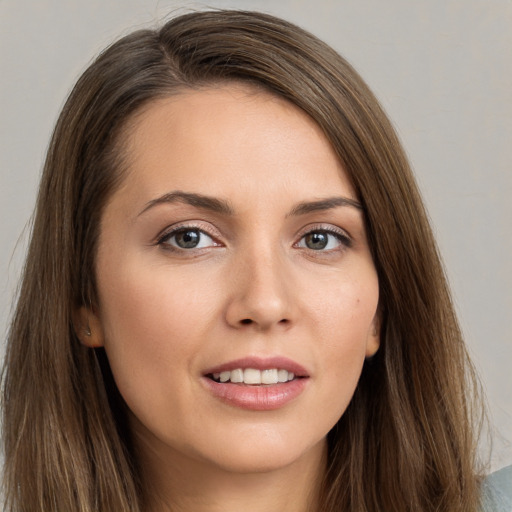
0,11,504,512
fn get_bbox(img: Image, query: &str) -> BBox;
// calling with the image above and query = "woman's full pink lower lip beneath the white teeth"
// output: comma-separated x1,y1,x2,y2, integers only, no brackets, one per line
203,377,308,411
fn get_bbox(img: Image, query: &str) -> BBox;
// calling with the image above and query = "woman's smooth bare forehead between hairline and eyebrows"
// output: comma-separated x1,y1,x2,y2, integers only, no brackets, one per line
115,84,355,209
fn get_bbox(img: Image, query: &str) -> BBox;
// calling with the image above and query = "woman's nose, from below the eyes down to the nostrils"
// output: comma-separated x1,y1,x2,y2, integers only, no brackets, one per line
226,248,295,331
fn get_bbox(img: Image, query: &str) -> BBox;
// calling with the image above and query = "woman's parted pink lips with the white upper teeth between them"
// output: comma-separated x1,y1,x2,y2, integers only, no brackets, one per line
202,357,309,411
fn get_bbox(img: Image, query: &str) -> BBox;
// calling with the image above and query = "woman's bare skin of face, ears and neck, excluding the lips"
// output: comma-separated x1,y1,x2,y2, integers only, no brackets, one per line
76,84,379,512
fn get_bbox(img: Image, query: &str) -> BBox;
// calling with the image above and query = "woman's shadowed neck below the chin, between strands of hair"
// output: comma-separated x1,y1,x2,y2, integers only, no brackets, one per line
138,432,326,512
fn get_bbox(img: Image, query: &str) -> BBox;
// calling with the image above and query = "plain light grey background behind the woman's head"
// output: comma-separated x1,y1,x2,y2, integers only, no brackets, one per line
0,0,512,469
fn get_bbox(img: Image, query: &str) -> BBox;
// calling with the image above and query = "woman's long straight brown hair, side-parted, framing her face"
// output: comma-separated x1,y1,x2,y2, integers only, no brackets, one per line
3,11,484,512
